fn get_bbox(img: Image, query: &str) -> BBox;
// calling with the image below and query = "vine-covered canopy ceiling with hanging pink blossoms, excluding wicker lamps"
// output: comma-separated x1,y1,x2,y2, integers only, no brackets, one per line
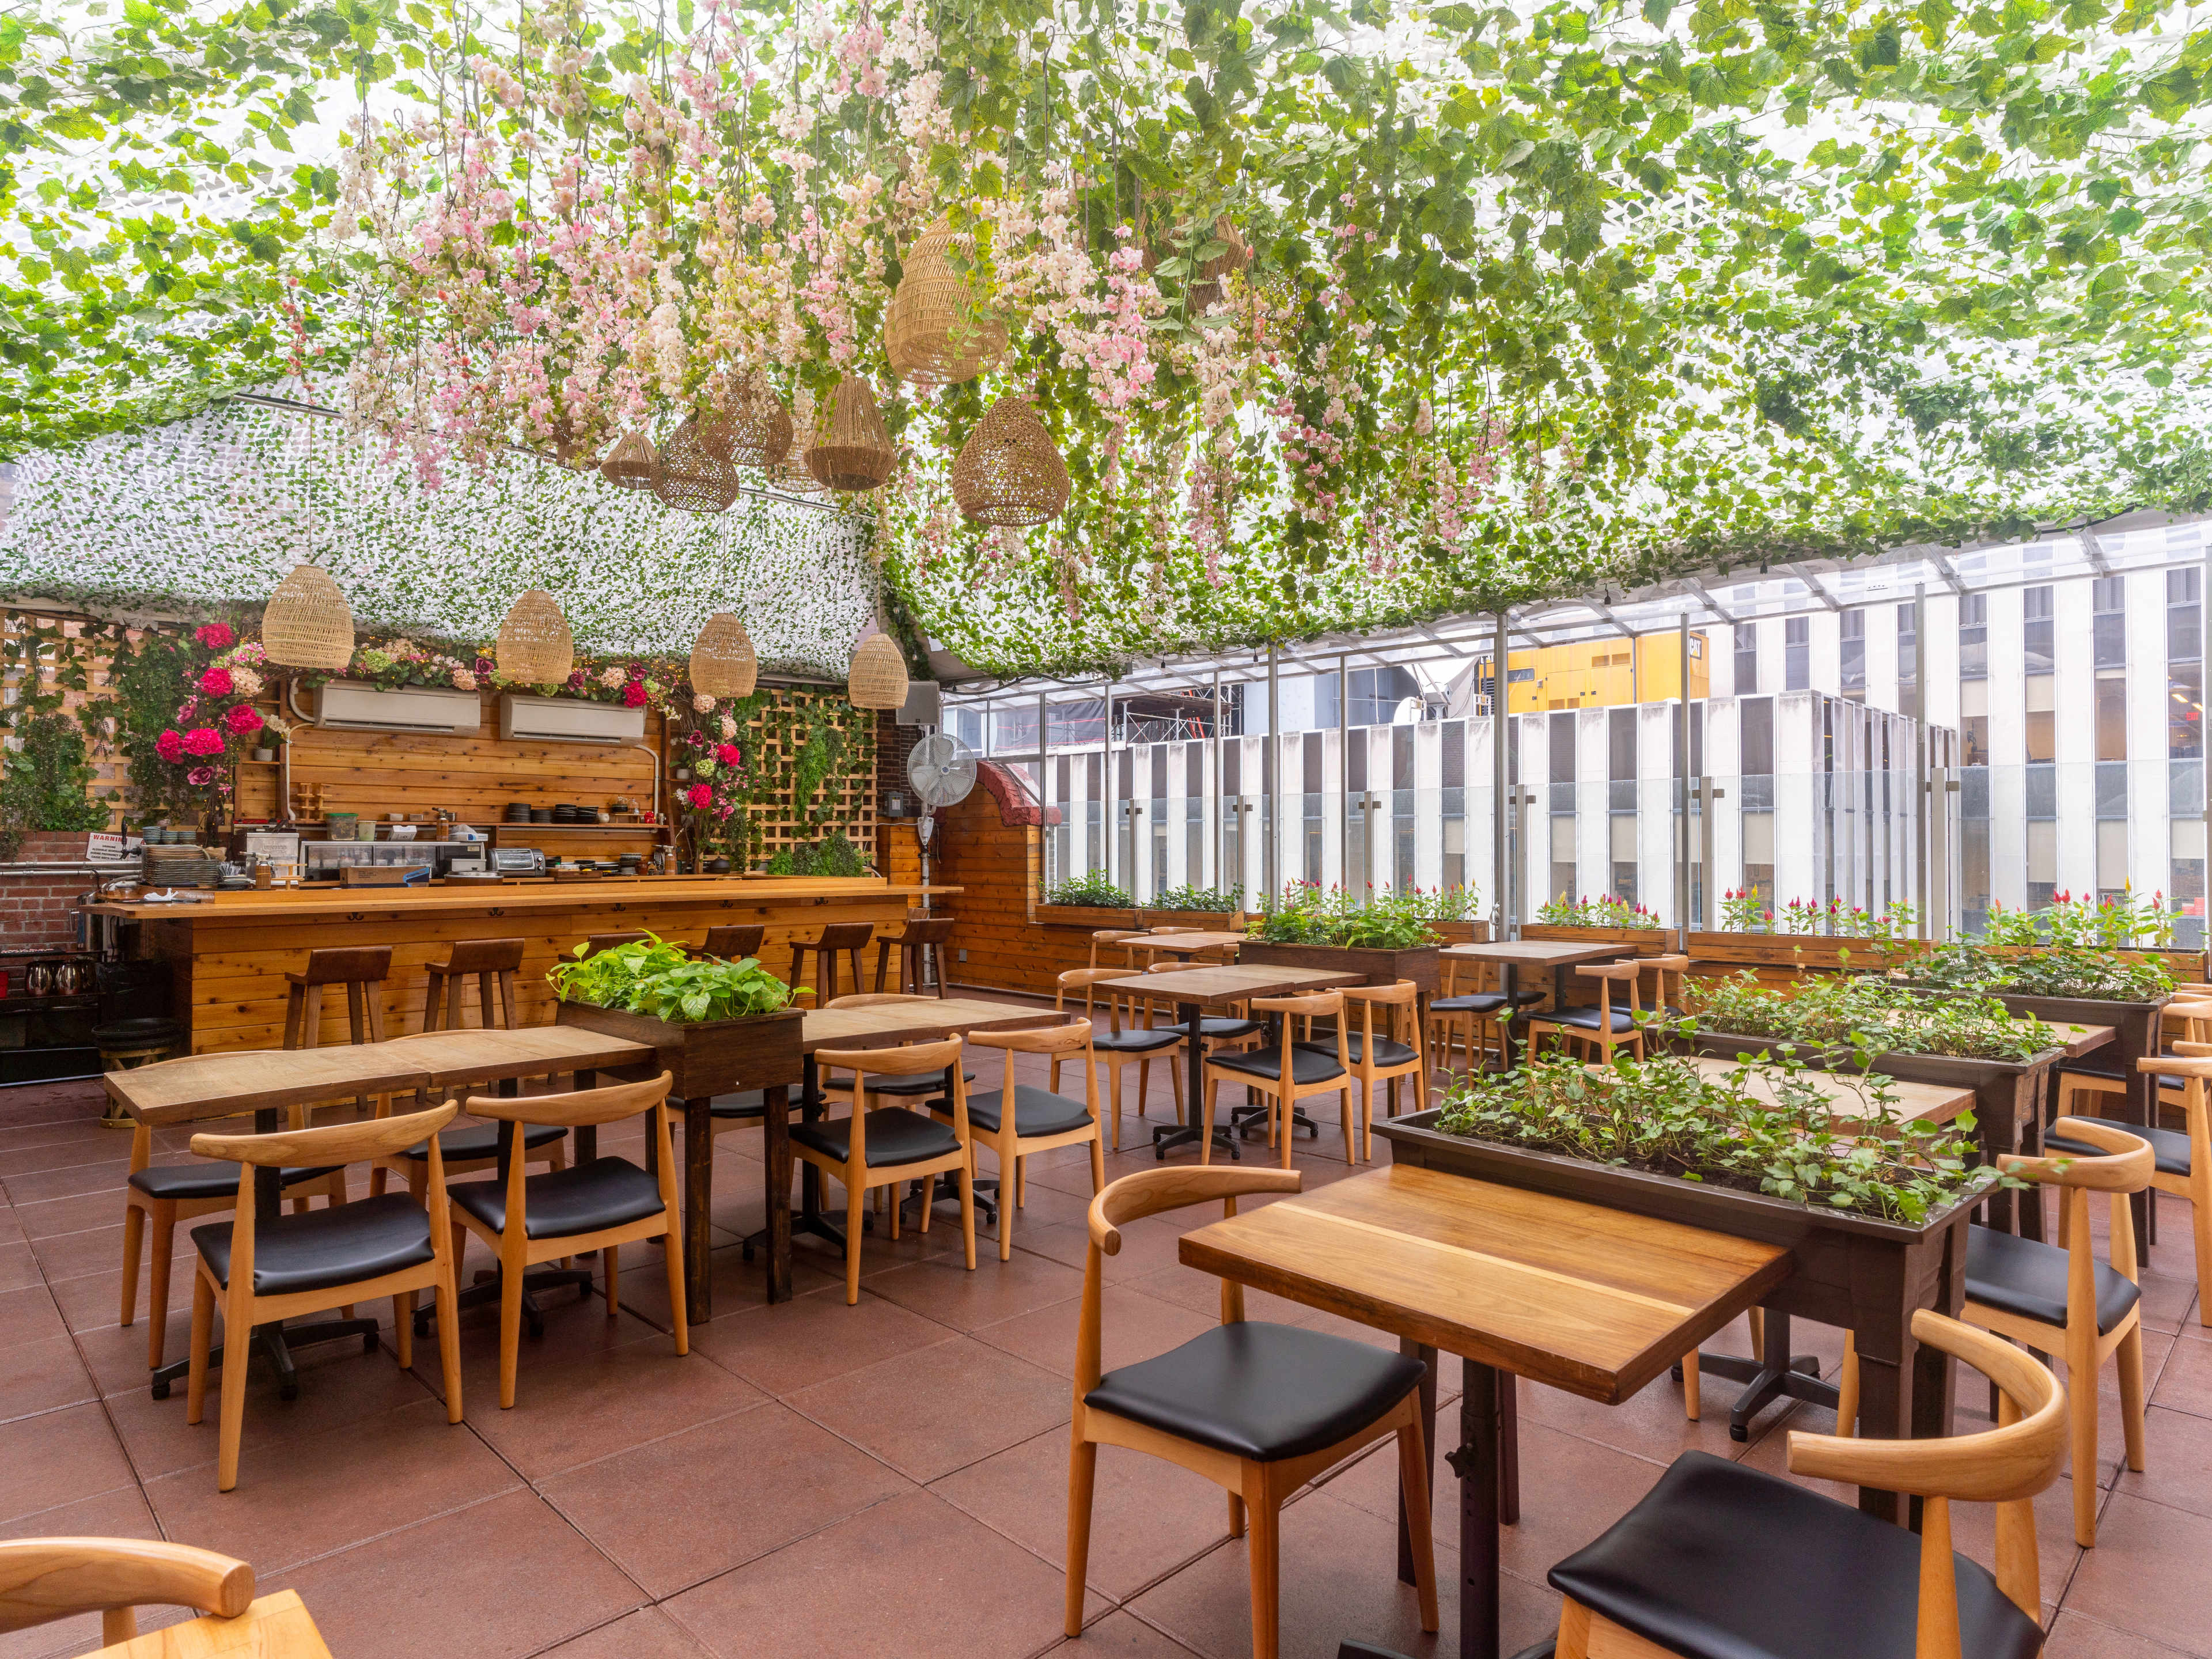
0,0,2212,672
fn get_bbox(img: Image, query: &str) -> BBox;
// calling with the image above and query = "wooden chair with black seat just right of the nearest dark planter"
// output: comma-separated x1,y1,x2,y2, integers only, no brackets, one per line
1955,1117,2152,1548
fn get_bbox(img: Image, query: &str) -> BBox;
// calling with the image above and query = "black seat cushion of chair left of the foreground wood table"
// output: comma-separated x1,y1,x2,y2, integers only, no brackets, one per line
1084,1320,1422,1462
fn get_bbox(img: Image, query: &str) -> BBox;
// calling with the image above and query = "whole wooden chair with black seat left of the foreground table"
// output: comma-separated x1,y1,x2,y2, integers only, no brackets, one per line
1066,1164,1435,1659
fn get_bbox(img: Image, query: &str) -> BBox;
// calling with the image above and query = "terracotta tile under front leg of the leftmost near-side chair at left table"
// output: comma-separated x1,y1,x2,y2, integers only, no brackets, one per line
146,1389,518,1573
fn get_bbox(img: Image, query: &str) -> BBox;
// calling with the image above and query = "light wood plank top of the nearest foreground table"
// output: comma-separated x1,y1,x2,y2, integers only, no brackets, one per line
1181,1164,1790,1404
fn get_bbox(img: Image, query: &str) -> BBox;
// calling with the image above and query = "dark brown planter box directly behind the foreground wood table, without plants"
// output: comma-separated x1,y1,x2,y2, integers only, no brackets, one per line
1376,1111,1973,1520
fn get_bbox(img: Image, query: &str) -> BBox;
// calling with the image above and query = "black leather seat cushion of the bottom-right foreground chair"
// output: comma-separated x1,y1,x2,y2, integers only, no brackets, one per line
1551,1451,2044,1659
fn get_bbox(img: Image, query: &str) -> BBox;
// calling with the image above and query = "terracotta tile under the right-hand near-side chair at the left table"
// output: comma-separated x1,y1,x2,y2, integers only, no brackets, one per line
453,1334,766,1480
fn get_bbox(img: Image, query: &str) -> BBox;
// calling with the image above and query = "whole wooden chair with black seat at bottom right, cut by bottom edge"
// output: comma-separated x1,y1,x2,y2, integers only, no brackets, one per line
1551,1309,2061,1659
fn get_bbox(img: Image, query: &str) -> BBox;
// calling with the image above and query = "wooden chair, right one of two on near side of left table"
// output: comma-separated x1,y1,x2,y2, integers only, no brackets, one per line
438,1071,690,1411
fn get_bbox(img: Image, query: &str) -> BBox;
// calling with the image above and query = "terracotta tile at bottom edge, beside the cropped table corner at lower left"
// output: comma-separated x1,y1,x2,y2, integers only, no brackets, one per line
266,1491,643,1659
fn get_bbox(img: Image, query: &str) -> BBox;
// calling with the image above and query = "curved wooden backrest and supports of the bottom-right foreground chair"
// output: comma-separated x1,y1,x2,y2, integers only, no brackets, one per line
1790,1318,2061,1659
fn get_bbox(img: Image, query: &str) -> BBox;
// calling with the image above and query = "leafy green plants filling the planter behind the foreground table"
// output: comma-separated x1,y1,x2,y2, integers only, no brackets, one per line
1435,1055,2017,1225
